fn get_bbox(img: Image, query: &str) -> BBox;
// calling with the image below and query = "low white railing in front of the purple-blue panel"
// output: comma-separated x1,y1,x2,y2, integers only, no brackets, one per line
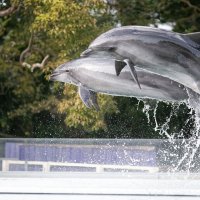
2,160,159,173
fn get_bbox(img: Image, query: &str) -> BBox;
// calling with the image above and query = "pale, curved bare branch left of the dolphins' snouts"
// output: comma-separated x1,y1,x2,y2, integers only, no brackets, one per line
19,33,49,72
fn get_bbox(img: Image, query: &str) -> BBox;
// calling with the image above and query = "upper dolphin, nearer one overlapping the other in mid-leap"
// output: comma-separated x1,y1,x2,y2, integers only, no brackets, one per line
81,26,200,94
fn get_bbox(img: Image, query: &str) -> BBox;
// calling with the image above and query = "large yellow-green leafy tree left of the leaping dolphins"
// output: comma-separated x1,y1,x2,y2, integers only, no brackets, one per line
0,0,117,136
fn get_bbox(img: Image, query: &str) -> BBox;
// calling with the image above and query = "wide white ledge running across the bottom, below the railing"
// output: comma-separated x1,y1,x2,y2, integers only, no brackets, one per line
0,172,200,198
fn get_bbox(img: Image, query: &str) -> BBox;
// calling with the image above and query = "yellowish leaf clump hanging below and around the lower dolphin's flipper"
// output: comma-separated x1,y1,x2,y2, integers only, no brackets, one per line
58,85,117,131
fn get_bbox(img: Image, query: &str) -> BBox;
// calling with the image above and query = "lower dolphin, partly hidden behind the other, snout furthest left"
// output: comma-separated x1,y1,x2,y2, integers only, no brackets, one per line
50,57,189,110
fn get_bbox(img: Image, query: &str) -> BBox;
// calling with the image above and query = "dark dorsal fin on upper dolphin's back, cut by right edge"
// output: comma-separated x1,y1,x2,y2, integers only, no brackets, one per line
181,32,200,50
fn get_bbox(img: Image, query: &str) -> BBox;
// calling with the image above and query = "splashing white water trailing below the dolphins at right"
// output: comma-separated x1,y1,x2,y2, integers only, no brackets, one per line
143,89,200,172
